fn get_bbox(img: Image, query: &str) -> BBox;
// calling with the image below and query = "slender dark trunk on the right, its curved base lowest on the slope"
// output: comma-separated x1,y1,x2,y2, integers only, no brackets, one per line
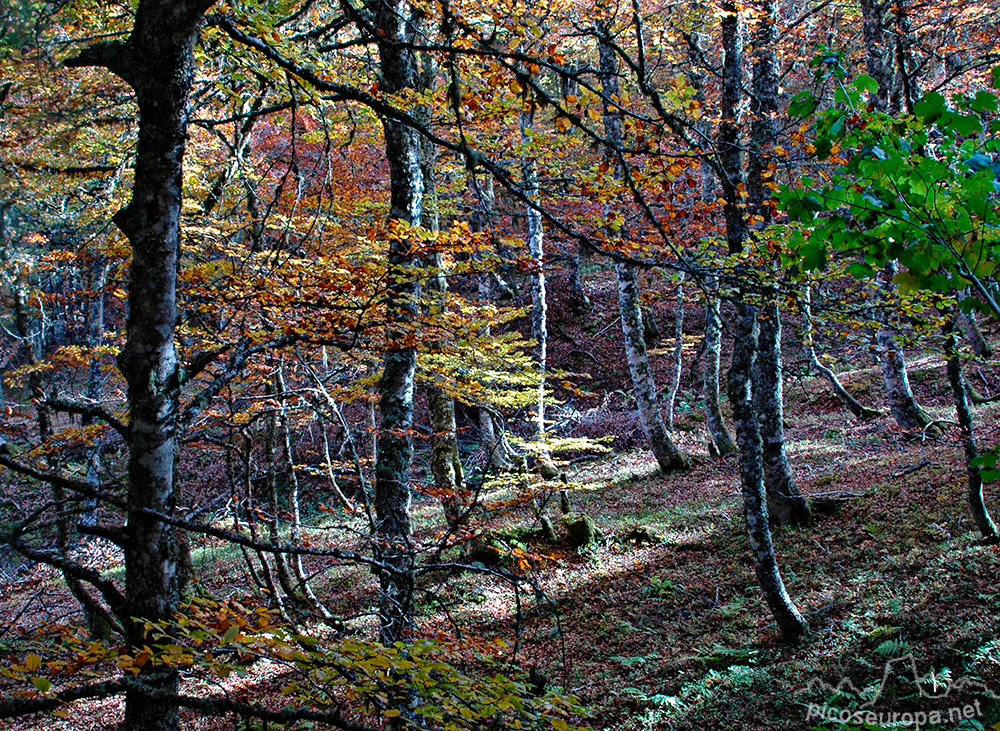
718,0,808,642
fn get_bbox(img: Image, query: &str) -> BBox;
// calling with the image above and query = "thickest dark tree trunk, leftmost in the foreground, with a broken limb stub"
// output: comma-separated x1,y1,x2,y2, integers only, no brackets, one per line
67,0,212,731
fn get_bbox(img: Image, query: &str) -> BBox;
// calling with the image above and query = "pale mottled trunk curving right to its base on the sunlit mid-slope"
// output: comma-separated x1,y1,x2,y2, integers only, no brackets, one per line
597,22,688,472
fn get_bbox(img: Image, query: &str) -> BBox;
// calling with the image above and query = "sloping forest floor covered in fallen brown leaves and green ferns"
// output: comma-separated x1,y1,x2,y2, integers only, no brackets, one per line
0,350,1000,731
